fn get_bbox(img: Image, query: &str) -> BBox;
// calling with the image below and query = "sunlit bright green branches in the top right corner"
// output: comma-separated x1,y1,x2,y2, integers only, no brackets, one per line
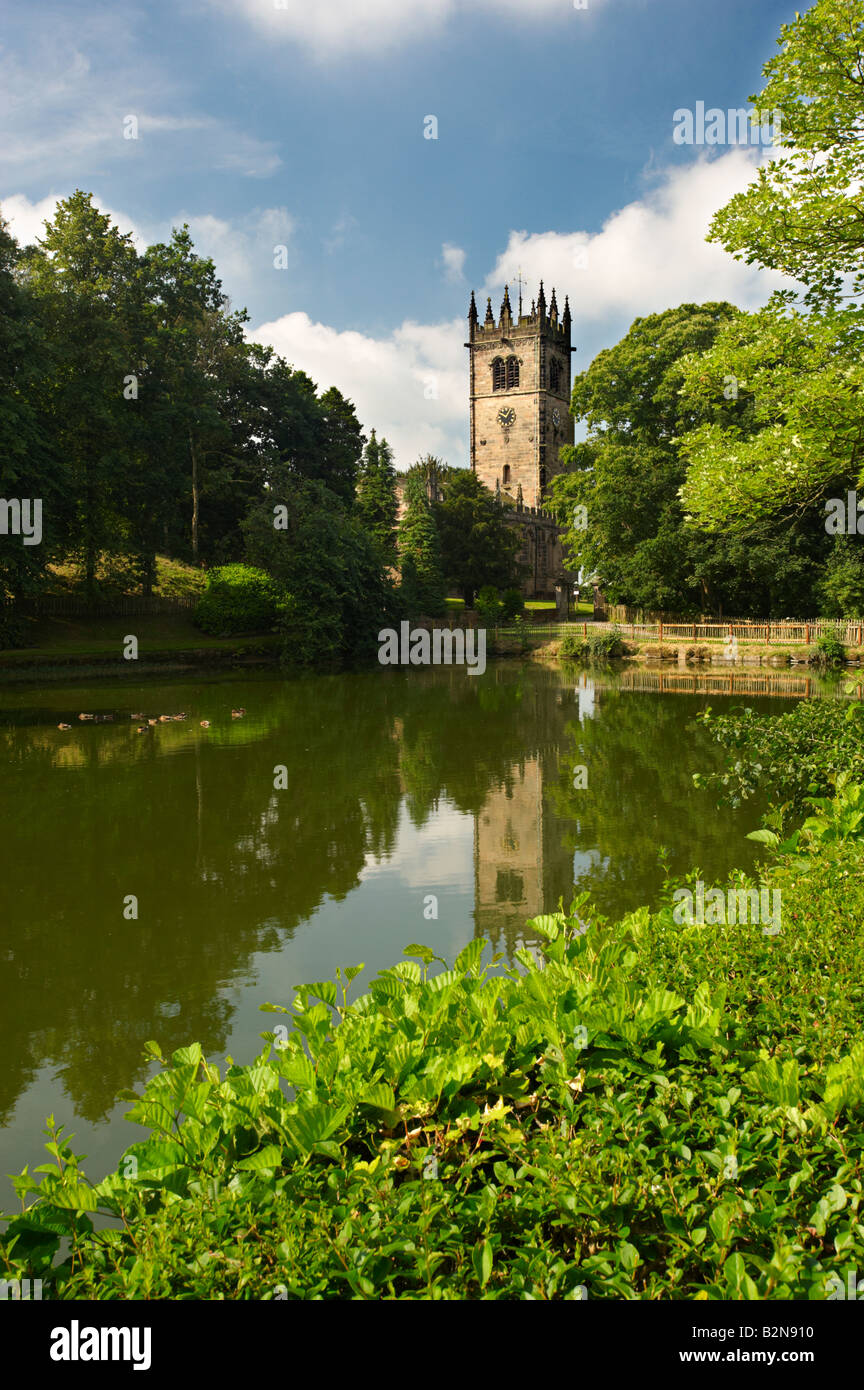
710,0,864,306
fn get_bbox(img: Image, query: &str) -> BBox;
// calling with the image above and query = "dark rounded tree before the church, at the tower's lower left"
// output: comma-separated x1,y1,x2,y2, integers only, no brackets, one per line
433,468,521,607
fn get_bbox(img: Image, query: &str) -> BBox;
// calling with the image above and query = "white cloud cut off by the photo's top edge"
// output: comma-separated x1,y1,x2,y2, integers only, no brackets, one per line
211,0,604,58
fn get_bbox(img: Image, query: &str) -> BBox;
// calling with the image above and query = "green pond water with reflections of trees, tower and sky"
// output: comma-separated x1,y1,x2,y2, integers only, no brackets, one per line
0,663,827,1205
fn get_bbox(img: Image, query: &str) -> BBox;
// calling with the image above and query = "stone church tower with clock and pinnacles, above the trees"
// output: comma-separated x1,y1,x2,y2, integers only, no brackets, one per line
465,281,575,507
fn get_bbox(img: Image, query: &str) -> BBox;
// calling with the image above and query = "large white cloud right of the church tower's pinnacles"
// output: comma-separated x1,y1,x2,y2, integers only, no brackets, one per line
485,149,789,360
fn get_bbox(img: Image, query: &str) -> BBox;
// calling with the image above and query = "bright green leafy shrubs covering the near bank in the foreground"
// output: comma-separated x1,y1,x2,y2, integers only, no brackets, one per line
0,811,864,1300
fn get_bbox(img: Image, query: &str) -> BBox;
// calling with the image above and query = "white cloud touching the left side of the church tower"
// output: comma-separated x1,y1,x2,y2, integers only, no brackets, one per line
249,313,468,468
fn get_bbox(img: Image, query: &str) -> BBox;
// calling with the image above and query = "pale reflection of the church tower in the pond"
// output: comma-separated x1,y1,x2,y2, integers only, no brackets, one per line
474,755,574,952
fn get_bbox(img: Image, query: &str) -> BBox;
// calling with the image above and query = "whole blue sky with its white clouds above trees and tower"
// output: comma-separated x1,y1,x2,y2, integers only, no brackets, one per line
0,0,800,467
